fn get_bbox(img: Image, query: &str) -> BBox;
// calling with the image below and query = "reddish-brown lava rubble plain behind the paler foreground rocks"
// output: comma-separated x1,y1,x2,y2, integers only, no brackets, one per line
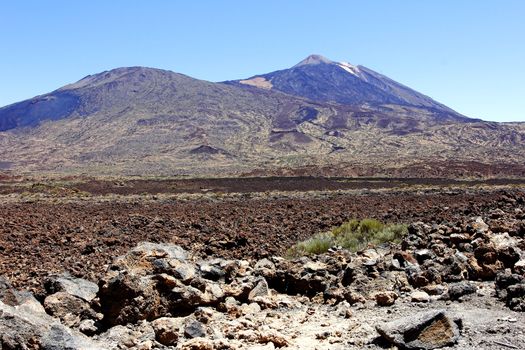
0,179,525,290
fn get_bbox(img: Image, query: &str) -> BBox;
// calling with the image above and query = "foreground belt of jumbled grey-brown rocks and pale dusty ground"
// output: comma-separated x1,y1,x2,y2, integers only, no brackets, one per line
0,200,525,349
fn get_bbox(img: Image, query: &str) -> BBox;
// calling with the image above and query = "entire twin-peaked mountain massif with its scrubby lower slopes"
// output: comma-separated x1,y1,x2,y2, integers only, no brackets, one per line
0,56,525,176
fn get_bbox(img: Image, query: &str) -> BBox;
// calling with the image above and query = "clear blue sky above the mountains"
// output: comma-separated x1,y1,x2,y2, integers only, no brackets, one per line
0,0,525,121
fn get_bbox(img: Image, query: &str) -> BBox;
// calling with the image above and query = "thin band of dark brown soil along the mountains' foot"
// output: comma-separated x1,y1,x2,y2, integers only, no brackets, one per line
0,176,525,195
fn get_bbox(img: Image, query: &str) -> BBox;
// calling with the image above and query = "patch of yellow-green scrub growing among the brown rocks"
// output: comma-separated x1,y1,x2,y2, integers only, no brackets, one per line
287,219,407,257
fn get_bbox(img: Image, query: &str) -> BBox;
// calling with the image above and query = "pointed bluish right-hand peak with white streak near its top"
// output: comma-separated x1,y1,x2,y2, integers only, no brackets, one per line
237,55,465,120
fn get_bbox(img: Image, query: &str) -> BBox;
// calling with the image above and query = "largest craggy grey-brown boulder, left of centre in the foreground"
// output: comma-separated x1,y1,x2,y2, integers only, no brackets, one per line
99,243,237,326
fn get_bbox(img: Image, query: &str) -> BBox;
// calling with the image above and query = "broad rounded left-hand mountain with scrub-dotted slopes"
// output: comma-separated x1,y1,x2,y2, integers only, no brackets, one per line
0,67,348,173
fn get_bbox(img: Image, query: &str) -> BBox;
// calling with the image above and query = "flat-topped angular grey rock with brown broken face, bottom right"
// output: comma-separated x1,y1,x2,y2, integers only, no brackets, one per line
376,310,460,350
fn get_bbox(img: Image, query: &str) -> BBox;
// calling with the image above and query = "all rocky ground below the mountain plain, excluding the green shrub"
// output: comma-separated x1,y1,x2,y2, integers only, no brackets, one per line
0,179,525,349
